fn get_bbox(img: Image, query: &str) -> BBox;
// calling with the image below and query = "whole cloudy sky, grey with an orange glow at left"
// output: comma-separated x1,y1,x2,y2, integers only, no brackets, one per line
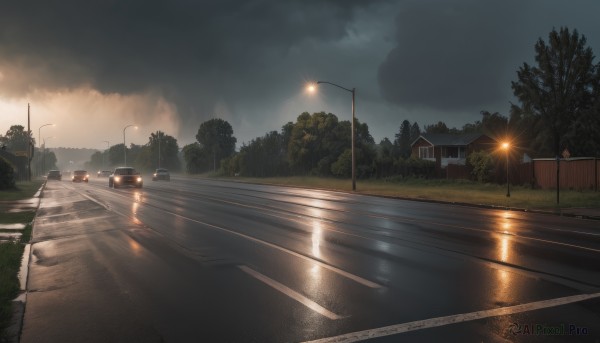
0,0,600,149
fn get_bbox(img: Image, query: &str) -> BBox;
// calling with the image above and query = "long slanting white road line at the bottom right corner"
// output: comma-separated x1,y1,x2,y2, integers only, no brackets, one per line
305,293,600,343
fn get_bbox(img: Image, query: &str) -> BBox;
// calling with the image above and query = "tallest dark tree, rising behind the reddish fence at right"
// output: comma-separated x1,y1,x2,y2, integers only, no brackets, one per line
512,28,600,156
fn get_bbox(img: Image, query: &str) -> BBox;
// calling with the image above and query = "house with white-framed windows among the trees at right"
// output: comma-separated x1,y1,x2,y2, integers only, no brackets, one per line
411,133,498,170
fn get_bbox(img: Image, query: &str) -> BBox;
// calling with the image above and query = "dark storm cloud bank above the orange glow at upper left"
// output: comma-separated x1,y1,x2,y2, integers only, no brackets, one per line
0,0,376,107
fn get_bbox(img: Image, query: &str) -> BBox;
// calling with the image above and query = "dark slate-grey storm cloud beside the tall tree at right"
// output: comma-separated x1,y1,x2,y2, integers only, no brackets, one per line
378,0,600,112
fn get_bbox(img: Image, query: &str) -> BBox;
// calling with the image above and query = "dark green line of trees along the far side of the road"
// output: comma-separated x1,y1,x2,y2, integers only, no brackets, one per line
0,28,600,184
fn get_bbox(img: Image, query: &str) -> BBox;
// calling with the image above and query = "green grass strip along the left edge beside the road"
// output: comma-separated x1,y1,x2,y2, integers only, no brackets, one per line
0,180,43,342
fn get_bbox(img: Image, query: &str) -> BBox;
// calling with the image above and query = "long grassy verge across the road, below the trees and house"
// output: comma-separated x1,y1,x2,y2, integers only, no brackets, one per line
214,176,600,210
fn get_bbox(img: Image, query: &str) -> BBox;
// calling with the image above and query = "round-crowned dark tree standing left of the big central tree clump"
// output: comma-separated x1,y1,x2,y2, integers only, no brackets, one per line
196,118,237,171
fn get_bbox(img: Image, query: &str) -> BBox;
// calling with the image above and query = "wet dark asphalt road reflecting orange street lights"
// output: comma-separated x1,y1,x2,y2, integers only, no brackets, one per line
21,177,600,342
